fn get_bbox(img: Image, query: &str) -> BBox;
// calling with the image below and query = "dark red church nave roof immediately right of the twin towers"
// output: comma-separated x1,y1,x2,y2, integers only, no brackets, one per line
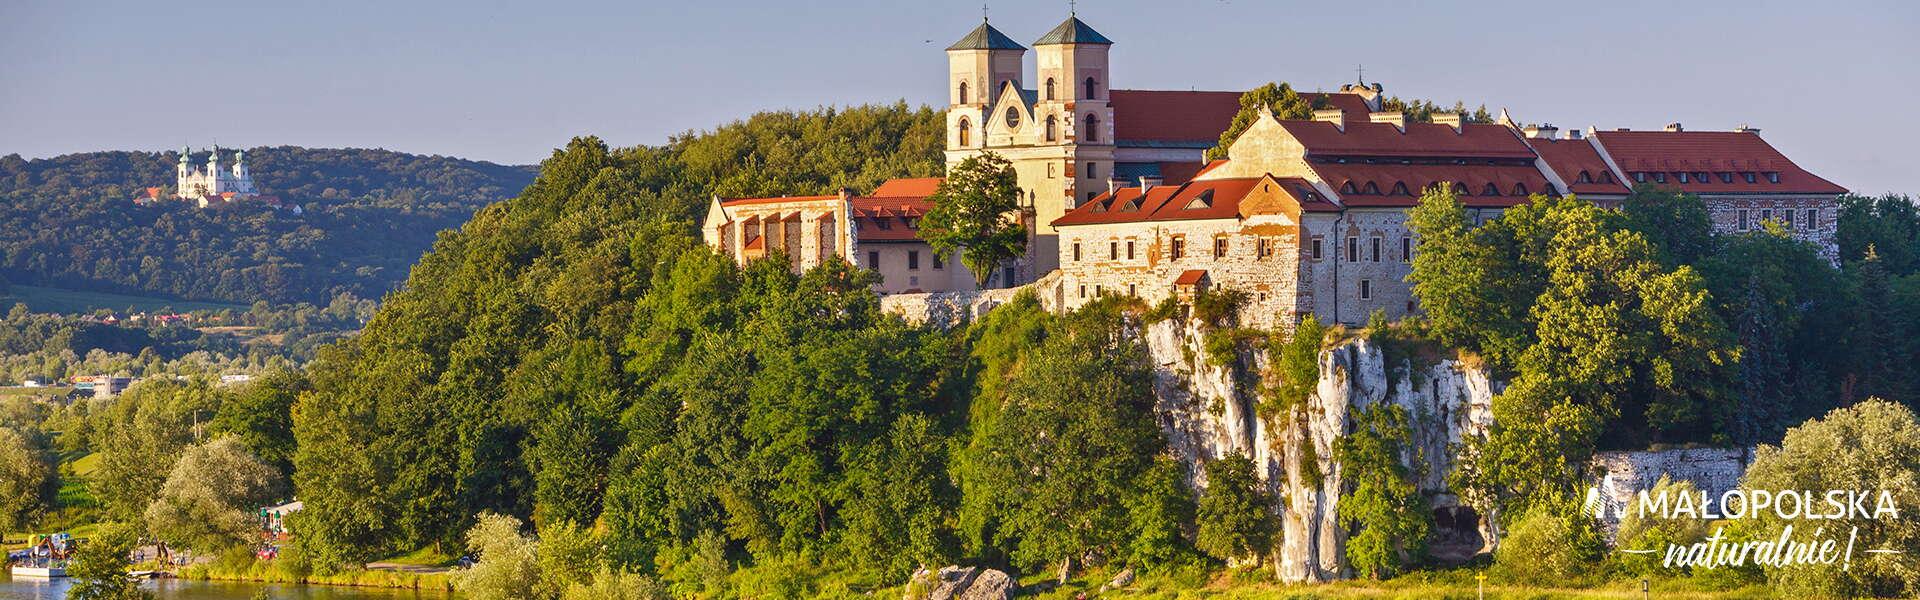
1108,90,1367,148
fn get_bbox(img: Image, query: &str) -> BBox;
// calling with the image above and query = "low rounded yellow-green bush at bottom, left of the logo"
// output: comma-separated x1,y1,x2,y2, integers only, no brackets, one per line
1492,502,1607,585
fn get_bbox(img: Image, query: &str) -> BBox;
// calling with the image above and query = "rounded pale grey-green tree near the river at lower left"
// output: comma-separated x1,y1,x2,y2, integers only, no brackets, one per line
146,437,286,554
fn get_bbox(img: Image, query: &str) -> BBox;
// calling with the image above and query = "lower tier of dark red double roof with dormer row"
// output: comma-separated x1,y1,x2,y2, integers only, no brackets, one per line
1311,162,1553,208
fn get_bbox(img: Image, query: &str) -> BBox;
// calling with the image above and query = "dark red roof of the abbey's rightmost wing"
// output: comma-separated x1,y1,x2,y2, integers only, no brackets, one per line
1594,131,1847,194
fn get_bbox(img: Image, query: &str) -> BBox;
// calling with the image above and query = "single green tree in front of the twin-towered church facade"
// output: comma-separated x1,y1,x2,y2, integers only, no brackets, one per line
918,152,1027,287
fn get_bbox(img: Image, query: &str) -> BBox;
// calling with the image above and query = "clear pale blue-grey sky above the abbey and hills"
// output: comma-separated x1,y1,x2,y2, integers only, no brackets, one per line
0,0,1920,194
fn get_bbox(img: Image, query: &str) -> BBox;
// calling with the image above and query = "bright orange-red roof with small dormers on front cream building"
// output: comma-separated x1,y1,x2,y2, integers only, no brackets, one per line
1052,177,1336,227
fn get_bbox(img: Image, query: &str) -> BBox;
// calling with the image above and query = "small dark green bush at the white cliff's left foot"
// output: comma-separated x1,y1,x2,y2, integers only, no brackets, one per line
1194,454,1279,563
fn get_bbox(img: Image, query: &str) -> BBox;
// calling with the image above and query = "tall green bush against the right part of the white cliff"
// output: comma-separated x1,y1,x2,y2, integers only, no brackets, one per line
1332,404,1432,579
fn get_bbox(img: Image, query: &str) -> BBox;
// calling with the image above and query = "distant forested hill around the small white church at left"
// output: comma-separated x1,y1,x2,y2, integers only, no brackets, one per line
0,146,536,304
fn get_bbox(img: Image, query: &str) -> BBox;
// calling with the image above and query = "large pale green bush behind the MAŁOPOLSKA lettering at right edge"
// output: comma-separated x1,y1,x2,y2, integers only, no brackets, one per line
1728,400,1920,598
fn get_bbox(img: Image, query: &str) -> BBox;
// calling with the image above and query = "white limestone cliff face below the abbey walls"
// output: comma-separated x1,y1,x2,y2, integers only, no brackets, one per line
1146,321,1498,581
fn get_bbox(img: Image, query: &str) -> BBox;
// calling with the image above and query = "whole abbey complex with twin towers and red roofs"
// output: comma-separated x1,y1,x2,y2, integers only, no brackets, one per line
703,17,1847,327
